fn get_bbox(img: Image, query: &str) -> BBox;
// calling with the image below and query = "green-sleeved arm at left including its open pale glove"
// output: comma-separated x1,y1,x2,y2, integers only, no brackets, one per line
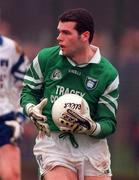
20,56,50,136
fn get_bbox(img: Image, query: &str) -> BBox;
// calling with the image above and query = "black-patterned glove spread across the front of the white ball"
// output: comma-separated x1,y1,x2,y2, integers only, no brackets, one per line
59,109,97,135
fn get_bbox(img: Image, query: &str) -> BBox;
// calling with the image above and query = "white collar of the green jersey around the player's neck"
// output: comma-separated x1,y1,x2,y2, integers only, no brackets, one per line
59,45,101,67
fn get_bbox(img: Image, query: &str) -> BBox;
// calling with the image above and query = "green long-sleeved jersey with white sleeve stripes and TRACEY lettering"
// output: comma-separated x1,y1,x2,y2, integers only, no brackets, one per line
21,46,119,138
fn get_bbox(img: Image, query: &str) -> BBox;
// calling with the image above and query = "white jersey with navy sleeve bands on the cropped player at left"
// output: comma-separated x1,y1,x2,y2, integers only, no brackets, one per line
0,36,29,116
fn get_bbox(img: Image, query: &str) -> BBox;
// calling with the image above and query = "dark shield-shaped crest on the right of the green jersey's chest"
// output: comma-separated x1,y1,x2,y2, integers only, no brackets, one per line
85,77,98,90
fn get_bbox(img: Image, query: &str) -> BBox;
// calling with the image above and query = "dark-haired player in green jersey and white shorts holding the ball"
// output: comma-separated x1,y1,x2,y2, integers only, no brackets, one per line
20,8,119,180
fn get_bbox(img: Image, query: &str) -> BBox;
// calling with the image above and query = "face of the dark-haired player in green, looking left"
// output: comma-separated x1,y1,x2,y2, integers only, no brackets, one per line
57,21,83,58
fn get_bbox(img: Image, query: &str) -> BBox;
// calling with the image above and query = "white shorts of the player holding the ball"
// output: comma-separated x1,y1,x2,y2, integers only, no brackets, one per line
33,132,112,180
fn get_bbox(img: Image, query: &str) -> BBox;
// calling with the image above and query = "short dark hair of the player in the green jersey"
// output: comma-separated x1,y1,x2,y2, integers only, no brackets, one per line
58,8,94,43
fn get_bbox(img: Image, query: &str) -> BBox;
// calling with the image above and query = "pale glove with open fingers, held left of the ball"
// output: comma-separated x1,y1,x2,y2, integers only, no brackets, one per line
27,98,50,136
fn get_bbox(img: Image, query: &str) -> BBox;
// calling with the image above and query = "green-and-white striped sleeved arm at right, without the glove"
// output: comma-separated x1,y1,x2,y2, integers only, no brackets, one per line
94,75,119,138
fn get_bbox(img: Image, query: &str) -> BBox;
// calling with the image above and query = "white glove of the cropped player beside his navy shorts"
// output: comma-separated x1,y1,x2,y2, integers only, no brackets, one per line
5,120,23,143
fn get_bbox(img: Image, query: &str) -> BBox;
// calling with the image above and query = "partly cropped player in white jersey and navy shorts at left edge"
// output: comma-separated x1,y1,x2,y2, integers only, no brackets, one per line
0,35,29,180
